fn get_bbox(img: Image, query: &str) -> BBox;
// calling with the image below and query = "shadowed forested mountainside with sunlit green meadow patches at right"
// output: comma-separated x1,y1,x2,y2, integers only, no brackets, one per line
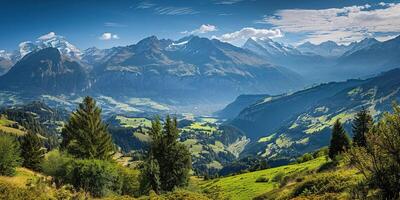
228,69,400,159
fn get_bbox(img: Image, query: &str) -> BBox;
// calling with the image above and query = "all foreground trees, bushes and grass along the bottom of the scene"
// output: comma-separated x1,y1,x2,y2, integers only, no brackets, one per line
0,97,400,200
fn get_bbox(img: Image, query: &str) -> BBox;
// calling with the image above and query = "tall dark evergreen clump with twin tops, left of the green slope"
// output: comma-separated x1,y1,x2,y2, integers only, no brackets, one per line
142,116,191,191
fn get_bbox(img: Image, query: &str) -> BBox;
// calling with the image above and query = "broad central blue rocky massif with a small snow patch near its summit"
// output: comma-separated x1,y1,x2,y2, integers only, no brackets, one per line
90,36,302,103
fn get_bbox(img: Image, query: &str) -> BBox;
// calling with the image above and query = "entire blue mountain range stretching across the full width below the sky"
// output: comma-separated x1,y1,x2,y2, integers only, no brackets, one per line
0,32,400,113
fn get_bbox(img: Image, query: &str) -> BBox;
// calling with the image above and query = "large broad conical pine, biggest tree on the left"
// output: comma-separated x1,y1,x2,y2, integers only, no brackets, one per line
61,97,114,160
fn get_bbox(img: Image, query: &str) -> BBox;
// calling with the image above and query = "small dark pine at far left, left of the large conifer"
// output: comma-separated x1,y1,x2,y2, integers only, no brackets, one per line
21,132,46,171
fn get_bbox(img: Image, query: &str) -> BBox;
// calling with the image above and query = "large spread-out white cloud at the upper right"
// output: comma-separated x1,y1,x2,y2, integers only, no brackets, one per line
259,2,400,44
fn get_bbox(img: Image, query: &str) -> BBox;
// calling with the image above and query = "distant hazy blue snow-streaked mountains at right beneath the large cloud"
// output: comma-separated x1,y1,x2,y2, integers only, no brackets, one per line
243,37,400,84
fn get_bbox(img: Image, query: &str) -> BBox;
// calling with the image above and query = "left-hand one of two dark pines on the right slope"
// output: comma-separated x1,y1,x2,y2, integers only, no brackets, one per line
329,119,350,160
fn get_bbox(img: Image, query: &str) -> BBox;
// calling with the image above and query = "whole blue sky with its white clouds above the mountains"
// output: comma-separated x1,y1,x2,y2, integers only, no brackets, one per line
0,0,400,51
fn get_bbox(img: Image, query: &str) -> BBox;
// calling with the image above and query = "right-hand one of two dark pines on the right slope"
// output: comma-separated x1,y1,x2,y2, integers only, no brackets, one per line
352,108,373,147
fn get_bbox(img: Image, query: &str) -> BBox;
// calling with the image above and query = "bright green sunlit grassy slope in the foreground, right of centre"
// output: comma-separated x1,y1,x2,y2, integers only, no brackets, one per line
200,157,326,200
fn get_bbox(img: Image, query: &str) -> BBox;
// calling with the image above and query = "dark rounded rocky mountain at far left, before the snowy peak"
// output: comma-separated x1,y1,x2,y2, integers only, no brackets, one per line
0,47,89,94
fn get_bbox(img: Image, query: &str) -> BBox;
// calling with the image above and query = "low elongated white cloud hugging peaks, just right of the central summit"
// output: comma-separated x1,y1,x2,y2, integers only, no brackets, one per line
213,27,283,45
